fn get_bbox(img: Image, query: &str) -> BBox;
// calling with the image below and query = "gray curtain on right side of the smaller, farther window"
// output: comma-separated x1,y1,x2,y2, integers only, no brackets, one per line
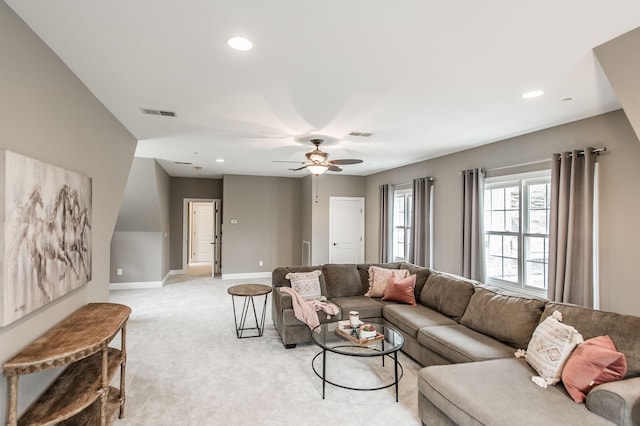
407,178,433,266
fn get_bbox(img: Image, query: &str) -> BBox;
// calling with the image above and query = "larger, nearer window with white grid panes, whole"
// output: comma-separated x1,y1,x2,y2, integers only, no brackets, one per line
484,171,551,294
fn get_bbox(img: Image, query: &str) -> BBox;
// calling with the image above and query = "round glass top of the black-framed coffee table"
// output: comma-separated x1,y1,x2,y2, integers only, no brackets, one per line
311,321,404,357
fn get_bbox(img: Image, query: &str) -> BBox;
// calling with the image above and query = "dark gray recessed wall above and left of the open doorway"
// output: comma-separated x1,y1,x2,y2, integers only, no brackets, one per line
169,177,224,270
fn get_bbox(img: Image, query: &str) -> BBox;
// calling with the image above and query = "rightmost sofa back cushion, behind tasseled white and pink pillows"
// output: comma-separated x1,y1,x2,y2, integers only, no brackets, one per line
541,302,640,377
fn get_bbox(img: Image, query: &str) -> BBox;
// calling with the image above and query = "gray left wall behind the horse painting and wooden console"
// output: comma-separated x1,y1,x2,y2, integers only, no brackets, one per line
0,2,136,421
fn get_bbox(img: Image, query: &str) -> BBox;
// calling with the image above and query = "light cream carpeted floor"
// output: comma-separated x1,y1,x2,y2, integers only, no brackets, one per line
110,277,420,425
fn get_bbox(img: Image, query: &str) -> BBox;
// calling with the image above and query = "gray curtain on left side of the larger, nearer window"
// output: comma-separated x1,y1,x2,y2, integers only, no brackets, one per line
462,169,484,282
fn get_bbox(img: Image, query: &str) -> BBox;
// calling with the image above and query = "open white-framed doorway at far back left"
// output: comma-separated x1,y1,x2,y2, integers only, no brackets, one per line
182,198,222,277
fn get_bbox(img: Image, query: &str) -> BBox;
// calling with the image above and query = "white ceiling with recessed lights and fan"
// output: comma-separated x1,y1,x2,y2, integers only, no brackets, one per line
5,0,640,177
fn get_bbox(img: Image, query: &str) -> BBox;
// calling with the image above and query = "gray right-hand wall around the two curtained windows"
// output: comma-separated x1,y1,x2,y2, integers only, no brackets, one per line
366,110,640,315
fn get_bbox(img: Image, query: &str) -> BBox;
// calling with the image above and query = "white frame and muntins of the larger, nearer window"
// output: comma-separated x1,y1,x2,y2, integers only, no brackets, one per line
482,169,551,297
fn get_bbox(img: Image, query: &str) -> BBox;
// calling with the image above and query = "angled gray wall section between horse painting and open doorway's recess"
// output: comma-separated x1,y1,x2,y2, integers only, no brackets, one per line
110,158,170,283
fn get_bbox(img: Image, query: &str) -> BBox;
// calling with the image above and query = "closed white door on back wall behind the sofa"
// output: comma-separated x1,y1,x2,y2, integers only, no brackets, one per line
329,197,364,263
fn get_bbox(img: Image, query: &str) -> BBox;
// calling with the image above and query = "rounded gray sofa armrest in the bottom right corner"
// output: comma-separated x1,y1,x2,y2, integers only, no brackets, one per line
586,377,640,426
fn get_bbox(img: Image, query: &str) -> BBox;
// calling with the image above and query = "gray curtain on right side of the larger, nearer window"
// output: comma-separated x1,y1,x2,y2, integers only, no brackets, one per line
548,148,596,307
